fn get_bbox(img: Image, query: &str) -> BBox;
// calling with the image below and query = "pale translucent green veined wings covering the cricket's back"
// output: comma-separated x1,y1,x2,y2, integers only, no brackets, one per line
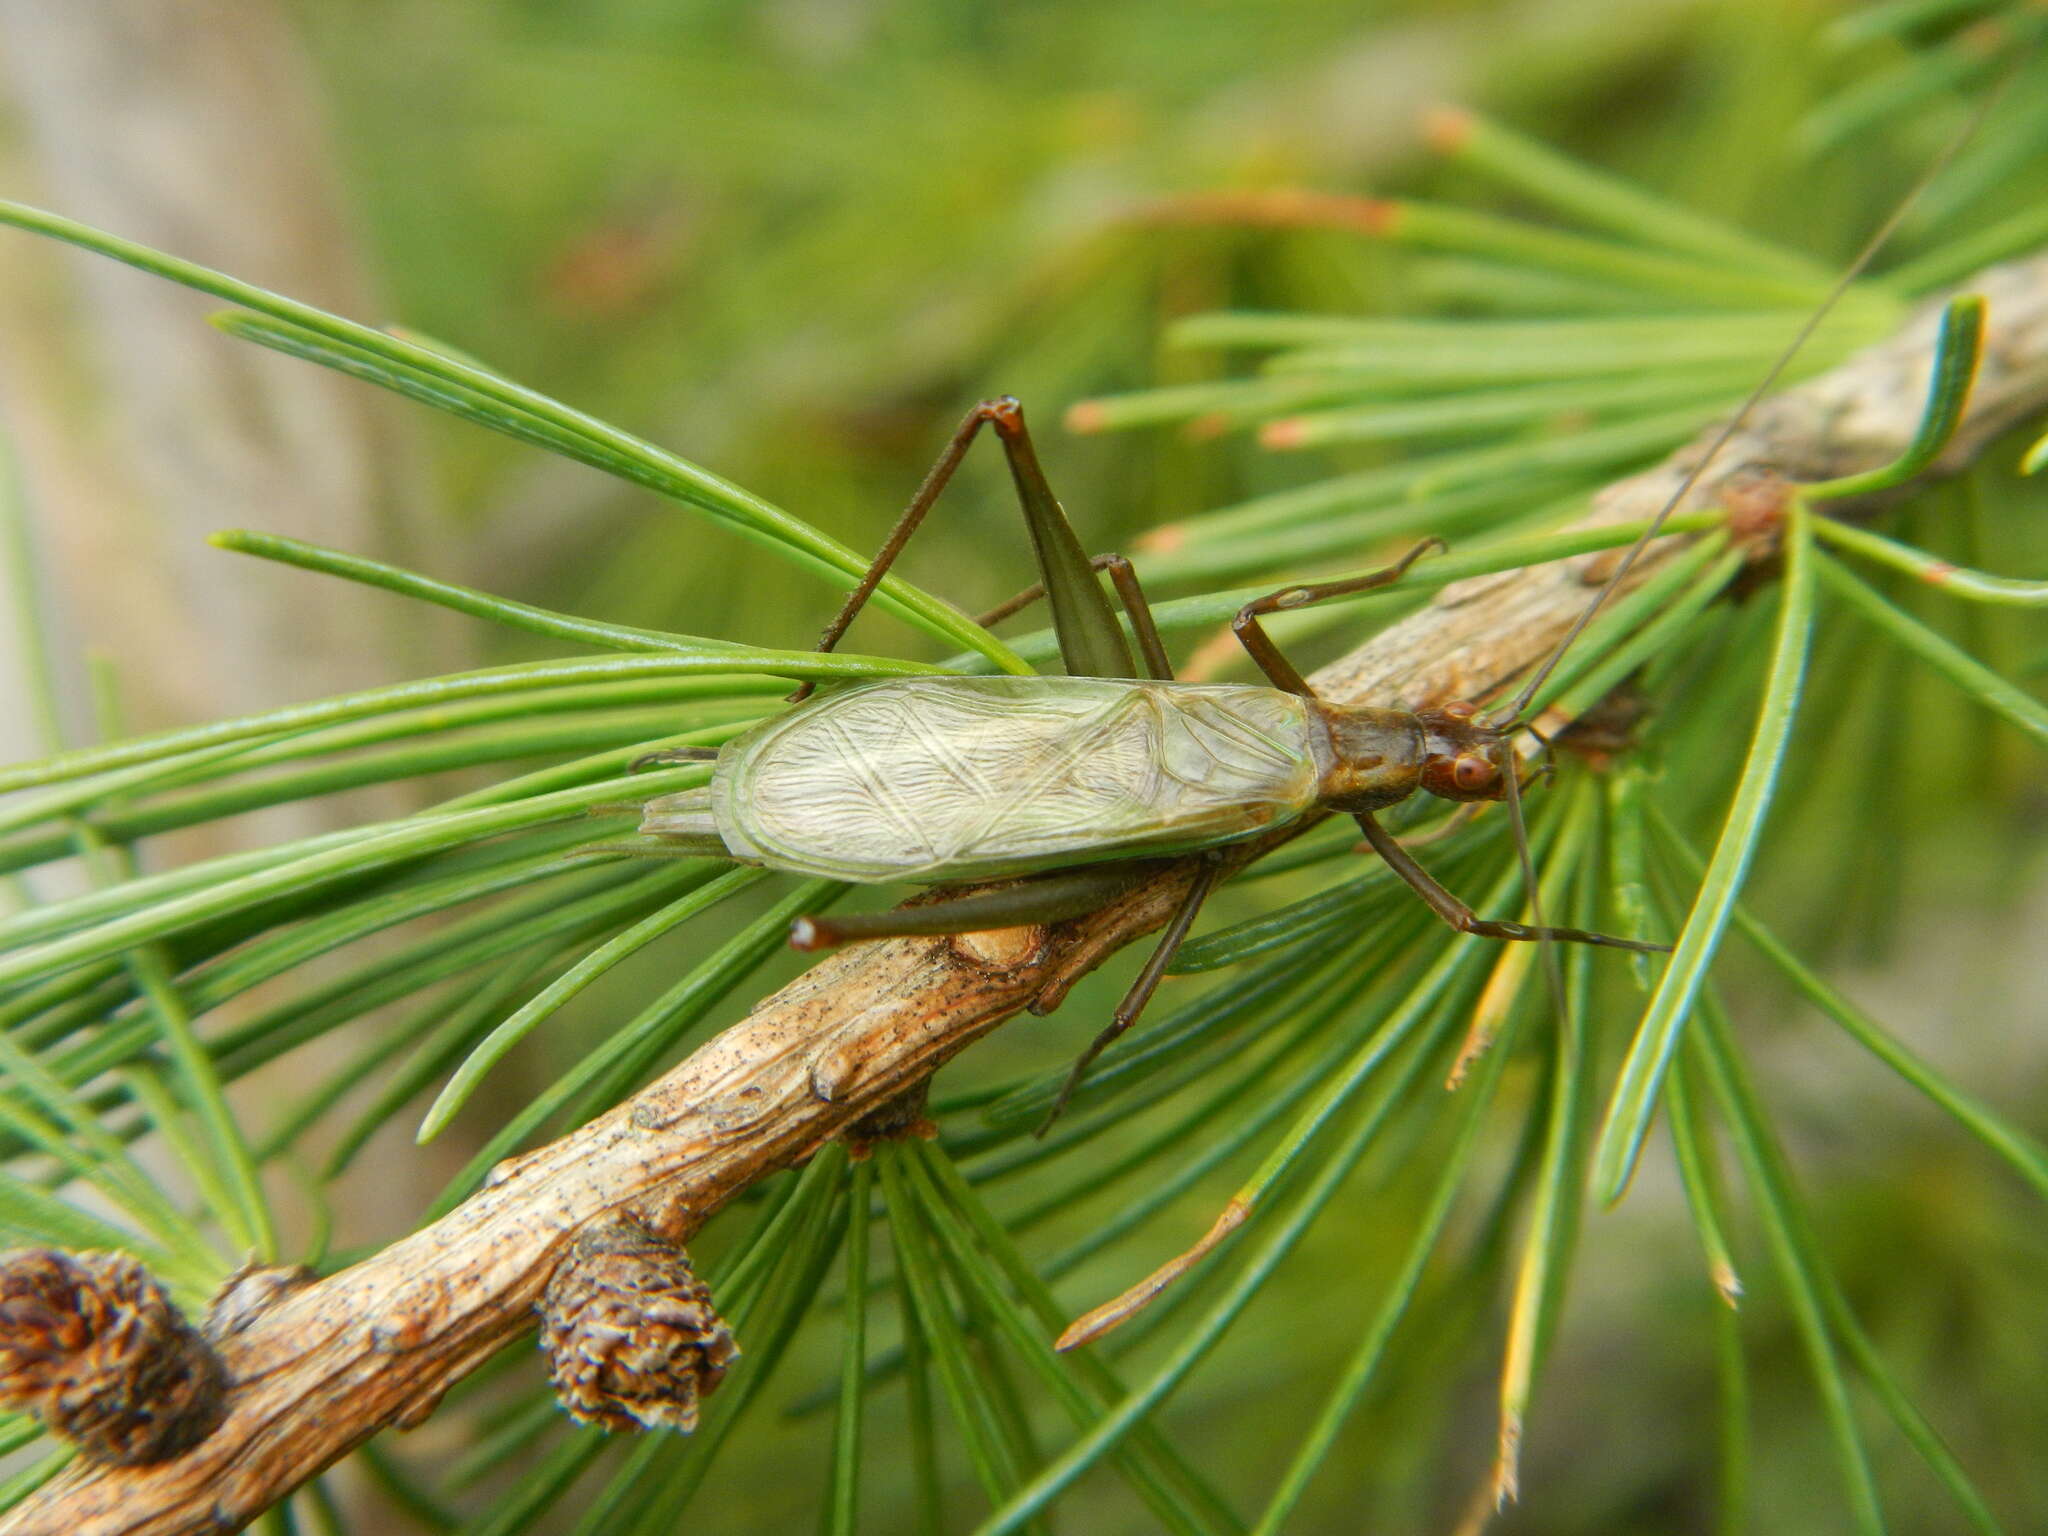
711,678,1317,883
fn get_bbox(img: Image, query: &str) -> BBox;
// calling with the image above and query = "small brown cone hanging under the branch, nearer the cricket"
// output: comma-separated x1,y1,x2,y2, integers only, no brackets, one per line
541,1217,739,1434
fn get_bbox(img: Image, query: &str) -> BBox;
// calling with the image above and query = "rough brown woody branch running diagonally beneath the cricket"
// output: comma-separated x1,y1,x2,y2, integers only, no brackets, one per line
0,258,2048,1536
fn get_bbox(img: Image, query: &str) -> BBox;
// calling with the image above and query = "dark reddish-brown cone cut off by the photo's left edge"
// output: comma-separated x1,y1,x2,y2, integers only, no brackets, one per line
0,1247,227,1466
